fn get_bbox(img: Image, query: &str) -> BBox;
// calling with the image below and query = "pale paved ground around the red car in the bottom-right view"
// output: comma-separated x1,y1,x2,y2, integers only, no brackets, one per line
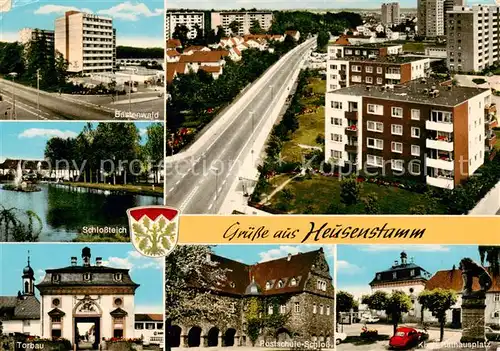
336,323,498,351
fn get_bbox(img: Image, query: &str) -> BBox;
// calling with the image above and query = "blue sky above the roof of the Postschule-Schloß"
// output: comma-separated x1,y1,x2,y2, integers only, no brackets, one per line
213,245,335,277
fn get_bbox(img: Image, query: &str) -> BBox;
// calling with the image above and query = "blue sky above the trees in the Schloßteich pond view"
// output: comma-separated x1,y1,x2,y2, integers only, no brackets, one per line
0,121,156,162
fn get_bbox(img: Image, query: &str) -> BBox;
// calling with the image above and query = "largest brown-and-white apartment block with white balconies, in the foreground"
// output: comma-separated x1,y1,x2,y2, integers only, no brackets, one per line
325,79,491,189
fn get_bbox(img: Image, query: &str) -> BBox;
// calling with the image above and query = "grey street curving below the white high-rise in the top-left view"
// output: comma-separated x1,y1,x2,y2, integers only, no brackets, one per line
0,79,164,120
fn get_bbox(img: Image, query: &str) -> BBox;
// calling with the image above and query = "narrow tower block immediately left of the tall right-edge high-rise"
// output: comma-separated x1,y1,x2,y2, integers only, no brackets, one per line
417,0,445,38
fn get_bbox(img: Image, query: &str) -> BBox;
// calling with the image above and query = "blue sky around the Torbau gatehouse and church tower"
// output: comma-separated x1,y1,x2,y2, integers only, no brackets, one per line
0,243,164,314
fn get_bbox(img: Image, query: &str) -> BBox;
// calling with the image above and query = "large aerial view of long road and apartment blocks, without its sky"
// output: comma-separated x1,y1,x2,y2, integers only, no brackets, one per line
165,1,500,215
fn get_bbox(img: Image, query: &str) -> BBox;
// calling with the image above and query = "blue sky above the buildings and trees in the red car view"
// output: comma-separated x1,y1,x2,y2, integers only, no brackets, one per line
337,245,480,297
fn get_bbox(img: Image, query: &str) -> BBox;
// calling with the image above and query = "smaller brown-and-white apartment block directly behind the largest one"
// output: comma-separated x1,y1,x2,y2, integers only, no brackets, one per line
326,55,430,91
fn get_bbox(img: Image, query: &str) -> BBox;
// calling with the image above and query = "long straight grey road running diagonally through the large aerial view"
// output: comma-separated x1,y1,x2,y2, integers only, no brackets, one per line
165,41,314,214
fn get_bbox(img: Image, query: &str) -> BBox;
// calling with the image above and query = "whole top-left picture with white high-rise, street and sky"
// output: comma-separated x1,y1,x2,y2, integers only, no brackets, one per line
0,0,165,121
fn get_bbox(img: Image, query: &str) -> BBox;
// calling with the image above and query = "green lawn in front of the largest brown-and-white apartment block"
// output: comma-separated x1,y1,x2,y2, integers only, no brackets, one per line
264,175,444,214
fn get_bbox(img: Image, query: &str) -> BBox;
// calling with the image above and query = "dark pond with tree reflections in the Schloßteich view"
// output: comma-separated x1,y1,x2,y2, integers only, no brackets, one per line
0,184,163,242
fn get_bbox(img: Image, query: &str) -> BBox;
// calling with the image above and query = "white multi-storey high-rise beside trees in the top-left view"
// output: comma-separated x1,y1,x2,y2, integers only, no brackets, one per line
54,11,116,74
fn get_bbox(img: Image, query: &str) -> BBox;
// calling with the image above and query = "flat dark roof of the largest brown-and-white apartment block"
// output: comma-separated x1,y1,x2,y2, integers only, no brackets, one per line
329,79,488,107
